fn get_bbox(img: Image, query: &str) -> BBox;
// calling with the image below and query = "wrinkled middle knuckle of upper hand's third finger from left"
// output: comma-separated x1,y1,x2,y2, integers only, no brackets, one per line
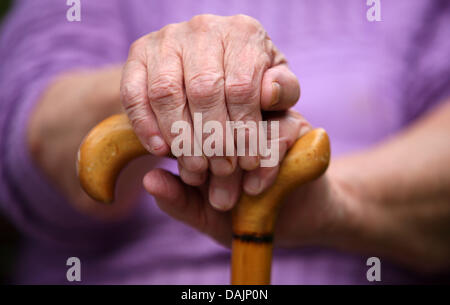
187,72,224,107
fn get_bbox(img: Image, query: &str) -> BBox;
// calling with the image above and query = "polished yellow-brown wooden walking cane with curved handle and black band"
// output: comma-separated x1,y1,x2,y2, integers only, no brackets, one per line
77,114,330,285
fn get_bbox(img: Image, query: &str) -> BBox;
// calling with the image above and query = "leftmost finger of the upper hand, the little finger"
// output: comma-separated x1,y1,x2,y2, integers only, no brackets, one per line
120,47,169,156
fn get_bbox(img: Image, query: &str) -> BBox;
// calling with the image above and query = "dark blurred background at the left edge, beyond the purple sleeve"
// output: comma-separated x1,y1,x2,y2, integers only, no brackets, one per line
0,0,19,284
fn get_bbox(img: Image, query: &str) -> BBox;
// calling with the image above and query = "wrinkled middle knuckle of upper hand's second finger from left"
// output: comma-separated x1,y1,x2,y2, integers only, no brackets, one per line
148,74,184,110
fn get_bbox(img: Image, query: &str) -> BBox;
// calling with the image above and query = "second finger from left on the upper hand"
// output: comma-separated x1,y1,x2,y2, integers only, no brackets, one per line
147,34,208,172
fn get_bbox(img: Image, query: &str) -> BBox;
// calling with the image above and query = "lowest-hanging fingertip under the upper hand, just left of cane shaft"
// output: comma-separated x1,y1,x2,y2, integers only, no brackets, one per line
209,167,242,211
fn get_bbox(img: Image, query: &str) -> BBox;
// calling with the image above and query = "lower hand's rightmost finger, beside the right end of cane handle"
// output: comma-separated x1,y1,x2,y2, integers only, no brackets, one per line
243,110,311,195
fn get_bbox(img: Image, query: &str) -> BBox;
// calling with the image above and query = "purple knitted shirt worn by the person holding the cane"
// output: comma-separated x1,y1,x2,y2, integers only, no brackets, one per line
0,0,450,284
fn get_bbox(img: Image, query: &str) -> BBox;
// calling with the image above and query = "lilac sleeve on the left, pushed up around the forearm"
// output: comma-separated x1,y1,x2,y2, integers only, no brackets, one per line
0,0,128,246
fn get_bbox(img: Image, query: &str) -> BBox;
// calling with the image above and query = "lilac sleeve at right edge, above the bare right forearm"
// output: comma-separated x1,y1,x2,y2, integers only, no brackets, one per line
402,1,450,122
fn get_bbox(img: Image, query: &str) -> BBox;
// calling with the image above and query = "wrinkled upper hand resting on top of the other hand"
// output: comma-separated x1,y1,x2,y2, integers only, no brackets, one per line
121,15,300,210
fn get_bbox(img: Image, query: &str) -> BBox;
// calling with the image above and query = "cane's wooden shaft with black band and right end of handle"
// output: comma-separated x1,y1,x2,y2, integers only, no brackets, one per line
231,128,330,285
